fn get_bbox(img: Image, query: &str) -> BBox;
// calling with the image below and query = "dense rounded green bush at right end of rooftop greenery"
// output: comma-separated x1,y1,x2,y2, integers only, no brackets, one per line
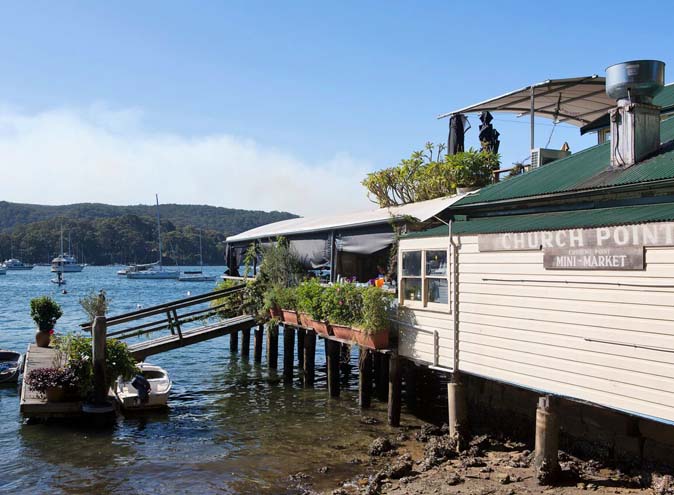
445,149,499,193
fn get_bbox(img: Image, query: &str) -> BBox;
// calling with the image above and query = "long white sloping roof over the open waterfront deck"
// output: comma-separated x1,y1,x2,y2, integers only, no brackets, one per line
226,193,473,243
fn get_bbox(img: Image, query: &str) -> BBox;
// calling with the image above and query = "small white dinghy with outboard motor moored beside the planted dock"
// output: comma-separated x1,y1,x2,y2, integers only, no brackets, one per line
113,363,173,410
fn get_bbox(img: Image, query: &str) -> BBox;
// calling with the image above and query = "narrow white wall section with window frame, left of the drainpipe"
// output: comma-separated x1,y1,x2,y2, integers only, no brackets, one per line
398,236,454,369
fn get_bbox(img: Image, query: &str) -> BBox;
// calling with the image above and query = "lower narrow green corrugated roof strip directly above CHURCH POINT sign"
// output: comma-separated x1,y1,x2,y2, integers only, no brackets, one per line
404,203,674,238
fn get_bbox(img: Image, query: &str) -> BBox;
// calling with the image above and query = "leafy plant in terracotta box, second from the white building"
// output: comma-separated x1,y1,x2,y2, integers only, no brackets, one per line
323,283,362,340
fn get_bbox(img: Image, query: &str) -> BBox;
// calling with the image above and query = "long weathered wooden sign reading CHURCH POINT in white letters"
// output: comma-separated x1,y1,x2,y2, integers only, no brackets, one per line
478,226,674,251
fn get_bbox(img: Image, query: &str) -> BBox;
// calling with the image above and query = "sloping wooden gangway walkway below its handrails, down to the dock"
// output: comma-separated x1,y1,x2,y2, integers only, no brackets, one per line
129,315,256,361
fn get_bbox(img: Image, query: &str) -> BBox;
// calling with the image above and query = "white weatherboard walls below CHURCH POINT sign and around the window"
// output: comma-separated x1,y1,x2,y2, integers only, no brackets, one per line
400,227,674,421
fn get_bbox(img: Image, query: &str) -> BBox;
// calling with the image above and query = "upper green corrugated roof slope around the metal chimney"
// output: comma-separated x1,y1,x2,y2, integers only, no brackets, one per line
454,118,674,207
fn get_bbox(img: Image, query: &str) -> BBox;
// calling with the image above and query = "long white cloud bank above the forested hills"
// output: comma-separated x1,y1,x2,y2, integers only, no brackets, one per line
0,105,373,215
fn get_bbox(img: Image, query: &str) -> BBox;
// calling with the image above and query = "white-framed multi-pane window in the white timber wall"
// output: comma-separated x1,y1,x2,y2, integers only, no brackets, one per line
400,249,449,310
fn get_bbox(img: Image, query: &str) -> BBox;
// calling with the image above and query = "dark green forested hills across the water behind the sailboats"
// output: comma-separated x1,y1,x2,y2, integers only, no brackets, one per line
0,202,295,265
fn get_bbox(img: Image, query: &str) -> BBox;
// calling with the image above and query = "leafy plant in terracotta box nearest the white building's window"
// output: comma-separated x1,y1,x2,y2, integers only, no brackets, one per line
353,287,394,349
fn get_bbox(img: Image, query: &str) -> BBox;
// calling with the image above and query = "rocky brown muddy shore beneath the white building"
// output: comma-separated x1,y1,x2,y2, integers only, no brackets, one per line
289,425,674,495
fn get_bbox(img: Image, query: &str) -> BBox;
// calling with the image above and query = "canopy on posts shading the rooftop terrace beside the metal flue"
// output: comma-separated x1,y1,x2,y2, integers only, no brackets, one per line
438,75,615,127
